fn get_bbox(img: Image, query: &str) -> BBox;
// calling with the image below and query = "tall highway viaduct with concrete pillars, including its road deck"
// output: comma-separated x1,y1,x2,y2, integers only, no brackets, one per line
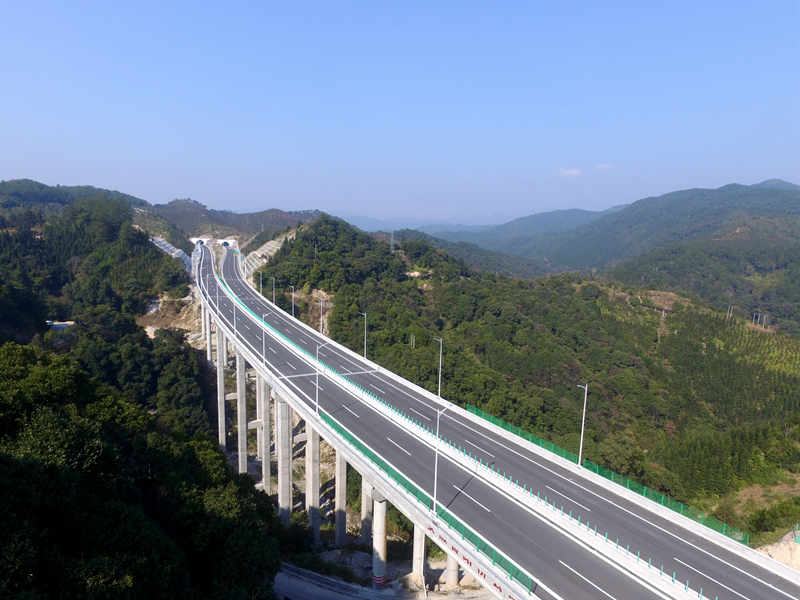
196,246,800,600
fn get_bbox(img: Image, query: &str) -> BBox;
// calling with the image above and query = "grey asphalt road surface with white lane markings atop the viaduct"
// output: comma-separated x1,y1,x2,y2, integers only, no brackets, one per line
199,246,800,600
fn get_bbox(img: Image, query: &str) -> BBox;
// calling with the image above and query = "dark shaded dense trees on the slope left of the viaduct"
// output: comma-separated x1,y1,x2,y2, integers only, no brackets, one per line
0,197,311,599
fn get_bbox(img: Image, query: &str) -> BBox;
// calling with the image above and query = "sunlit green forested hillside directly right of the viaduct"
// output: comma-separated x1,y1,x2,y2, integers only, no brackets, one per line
265,217,800,540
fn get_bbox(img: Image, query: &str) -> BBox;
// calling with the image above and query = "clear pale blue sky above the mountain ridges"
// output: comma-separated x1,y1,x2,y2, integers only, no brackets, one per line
0,0,800,222
